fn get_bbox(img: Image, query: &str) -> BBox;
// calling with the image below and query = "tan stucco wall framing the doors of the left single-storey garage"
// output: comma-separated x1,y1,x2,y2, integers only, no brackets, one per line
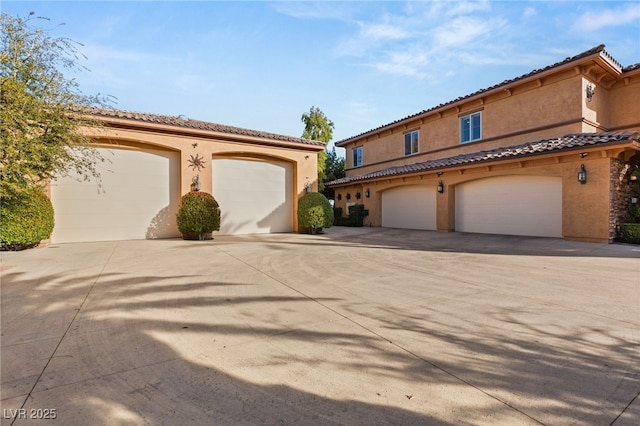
83,126,318,231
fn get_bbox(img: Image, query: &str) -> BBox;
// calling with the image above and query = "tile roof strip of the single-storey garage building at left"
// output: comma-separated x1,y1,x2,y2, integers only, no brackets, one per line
86,108,325,146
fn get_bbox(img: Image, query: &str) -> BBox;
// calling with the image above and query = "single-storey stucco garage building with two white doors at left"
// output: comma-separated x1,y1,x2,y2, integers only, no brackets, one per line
50,109,324,243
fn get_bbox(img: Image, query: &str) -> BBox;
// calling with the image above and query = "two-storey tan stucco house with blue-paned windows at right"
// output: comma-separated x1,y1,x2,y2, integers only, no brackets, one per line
326,45,640,241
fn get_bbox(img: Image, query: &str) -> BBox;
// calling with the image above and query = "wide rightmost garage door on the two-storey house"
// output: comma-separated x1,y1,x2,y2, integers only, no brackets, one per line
456,176,562,237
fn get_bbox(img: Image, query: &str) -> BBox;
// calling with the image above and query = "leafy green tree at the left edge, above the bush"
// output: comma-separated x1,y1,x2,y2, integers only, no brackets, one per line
0,12,105,201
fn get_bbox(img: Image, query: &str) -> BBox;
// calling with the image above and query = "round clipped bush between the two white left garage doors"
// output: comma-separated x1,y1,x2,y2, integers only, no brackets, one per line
176,191,220,240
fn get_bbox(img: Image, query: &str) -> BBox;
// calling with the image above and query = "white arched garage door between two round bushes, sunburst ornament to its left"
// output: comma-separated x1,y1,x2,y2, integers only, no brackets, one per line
211,158,293,235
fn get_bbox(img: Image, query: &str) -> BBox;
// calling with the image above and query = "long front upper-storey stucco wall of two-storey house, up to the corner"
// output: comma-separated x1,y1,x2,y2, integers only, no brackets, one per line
346,75,592,176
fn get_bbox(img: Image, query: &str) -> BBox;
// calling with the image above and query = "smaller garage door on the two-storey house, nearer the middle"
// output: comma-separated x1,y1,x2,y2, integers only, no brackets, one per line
382,185,436,230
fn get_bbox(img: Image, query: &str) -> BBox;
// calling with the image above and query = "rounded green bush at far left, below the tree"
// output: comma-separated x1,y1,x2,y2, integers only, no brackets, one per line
0,187,54,251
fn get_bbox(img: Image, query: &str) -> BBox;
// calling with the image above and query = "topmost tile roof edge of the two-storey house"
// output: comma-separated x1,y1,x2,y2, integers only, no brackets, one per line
336,44,632,146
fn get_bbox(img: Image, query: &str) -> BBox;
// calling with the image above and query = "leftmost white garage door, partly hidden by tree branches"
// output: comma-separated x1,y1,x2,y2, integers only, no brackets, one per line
51,148,180,243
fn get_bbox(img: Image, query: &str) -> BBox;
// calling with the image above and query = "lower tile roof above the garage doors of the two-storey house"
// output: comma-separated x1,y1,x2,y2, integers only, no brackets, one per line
325,132,640,186
